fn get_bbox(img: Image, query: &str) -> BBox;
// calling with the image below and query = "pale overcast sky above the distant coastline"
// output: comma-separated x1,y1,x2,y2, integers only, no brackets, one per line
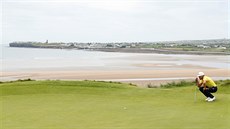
0,0,230,44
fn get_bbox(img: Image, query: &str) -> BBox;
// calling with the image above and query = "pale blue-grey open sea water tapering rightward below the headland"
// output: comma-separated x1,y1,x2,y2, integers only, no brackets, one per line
0,46,129,71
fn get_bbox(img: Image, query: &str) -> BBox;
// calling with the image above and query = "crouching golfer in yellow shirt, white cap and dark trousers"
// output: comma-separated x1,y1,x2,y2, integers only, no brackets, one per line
196,72,217,102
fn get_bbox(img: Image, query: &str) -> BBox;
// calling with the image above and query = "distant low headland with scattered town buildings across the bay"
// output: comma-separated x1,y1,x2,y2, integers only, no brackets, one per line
9,39,230,55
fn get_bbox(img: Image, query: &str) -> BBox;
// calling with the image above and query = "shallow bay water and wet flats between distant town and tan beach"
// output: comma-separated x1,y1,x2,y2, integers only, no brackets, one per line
0,45,230,72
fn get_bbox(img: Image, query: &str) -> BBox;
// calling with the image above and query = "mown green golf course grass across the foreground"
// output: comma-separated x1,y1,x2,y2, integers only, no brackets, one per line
0,80,230,129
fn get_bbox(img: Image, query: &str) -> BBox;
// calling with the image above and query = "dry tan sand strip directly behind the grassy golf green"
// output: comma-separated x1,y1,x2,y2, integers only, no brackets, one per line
1,69,230,87
